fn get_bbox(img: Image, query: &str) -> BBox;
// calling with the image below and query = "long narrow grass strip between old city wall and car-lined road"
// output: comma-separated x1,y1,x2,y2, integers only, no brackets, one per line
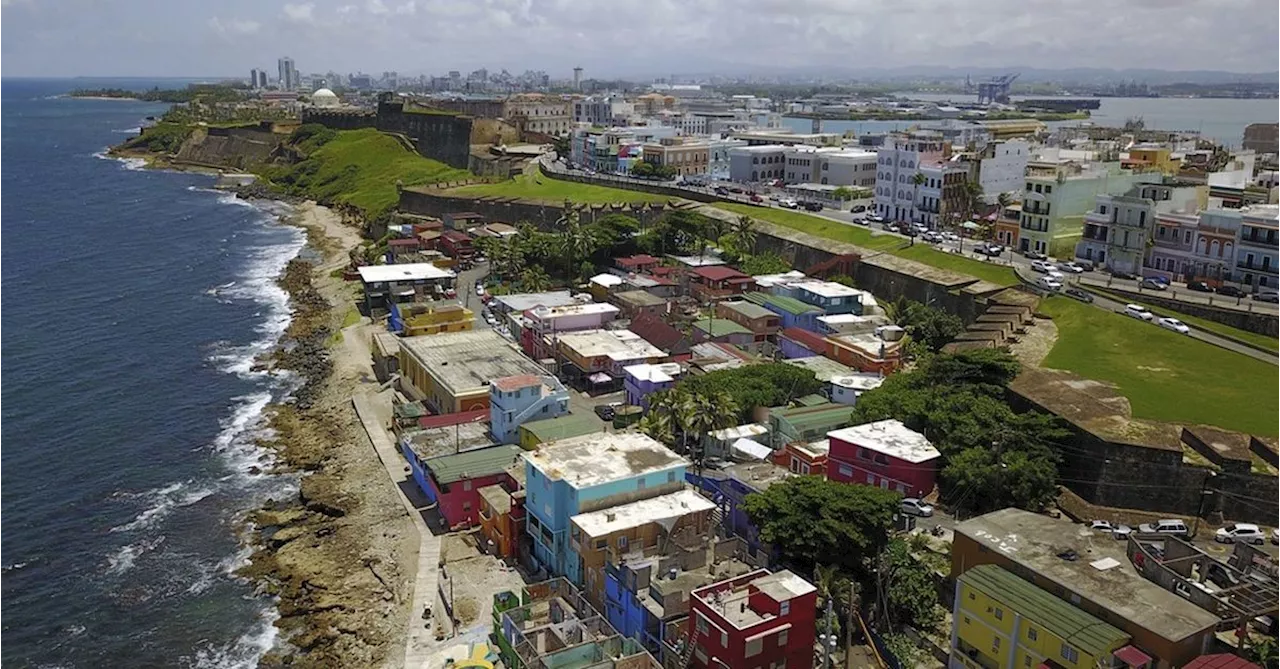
716,202,1018,285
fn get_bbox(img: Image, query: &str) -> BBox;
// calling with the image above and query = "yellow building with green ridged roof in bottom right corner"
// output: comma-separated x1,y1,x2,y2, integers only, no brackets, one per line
948,564,1129,669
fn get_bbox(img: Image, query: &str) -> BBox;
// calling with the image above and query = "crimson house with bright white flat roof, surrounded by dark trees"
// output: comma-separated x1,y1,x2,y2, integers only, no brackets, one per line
827,420,942,498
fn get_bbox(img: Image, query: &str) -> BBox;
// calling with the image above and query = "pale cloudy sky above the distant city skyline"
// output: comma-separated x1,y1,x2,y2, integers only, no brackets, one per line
0,0,1280,78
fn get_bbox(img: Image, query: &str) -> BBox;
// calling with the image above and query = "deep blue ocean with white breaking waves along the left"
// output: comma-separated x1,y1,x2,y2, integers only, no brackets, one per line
0,79,305,668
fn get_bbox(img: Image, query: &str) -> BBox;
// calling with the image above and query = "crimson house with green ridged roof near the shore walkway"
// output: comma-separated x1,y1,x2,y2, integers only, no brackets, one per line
420,445,524,527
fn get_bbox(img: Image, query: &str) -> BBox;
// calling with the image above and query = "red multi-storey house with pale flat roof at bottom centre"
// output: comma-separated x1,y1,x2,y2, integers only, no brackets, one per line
689,569,818,669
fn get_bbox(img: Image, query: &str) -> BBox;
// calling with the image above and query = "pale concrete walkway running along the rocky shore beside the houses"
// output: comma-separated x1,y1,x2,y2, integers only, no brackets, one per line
352,391,453,669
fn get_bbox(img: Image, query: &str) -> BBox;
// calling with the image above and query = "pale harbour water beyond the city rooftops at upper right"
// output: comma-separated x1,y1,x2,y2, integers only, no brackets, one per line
783,93,1280,148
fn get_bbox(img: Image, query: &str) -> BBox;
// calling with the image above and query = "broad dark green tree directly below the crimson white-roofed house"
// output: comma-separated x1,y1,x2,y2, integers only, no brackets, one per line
742,476,901,574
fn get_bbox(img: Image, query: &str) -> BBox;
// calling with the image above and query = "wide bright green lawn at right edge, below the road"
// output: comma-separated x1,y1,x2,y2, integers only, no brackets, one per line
1041,297,1280,436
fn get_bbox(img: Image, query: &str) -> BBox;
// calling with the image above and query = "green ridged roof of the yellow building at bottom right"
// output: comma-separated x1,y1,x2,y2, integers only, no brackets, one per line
960,564,1129,657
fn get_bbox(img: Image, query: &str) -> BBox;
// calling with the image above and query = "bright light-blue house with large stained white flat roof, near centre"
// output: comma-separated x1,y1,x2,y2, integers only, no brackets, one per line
525,432,689,585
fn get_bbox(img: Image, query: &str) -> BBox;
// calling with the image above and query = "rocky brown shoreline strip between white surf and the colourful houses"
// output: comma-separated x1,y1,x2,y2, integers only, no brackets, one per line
244,202,419,666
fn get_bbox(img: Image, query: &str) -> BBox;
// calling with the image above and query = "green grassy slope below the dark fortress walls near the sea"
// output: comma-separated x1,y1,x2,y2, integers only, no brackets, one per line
264,127,471,219
